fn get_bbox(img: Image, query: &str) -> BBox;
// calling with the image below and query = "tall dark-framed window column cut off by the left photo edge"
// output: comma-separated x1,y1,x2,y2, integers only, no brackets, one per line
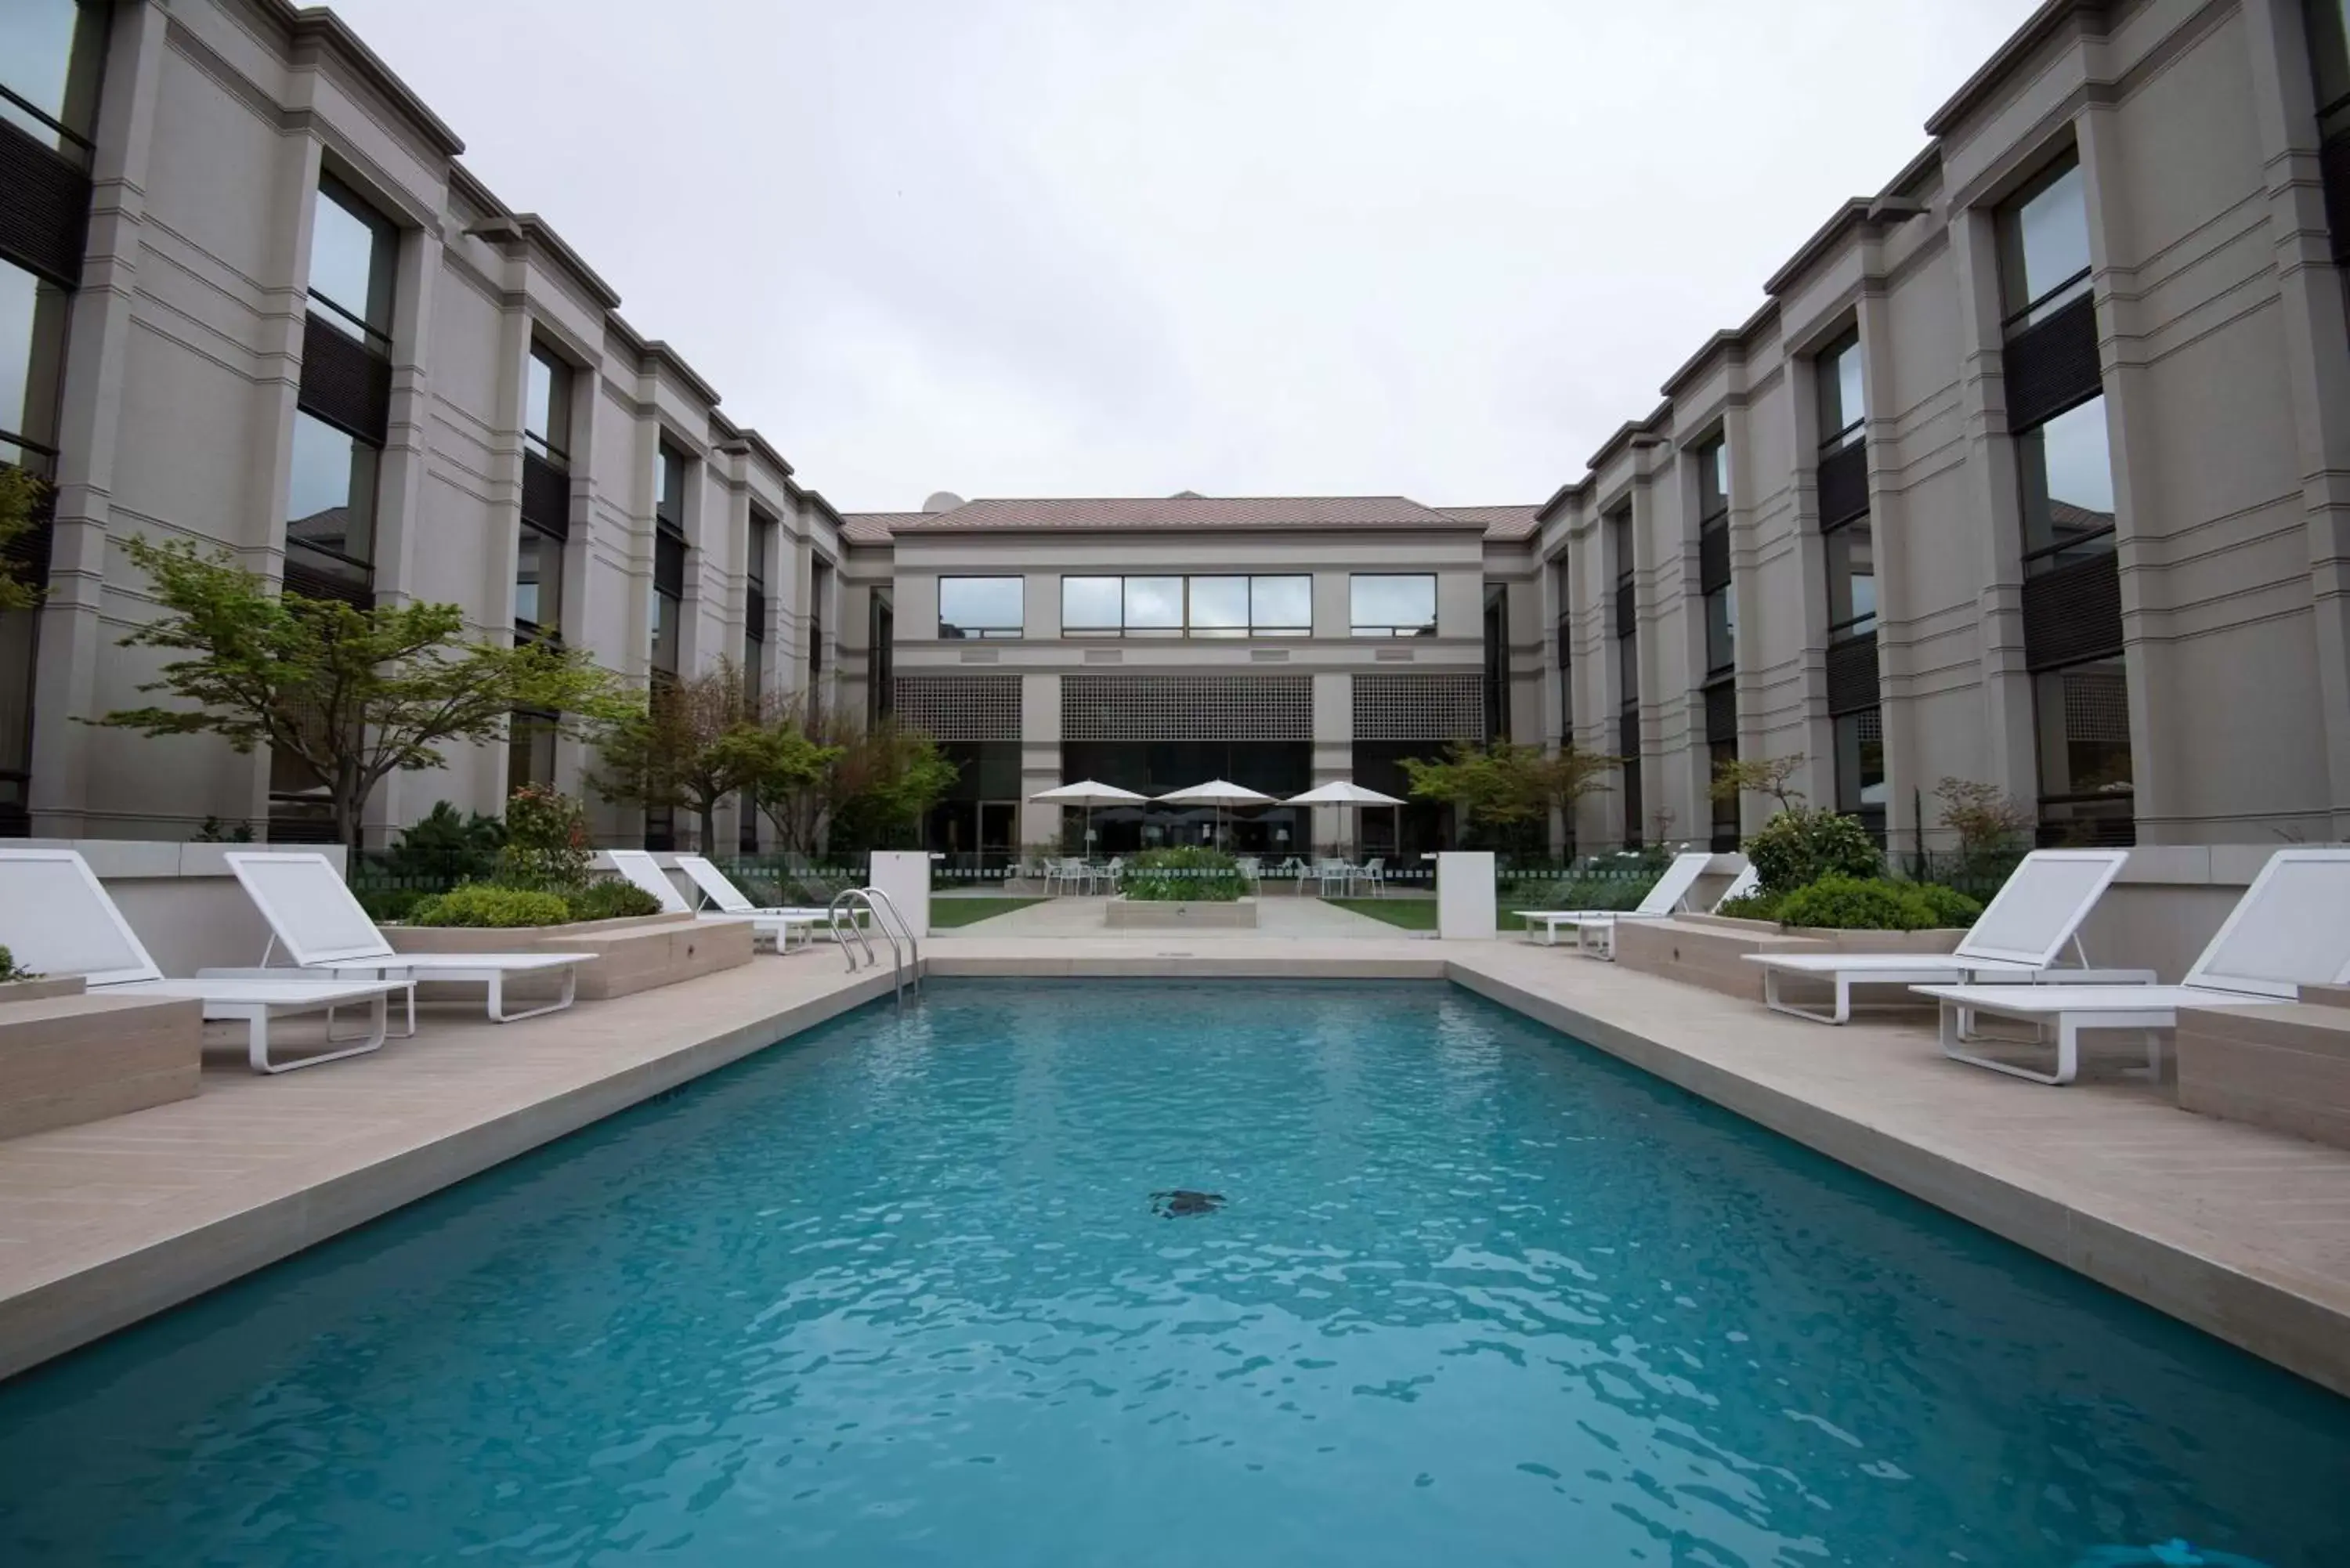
0,0,108,837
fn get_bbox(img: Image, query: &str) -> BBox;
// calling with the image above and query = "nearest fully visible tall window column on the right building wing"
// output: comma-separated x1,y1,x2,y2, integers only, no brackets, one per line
1998,153,2134,844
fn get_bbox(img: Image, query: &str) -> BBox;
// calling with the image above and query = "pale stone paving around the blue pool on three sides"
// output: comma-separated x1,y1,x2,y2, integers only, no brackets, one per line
0,930,2350,1394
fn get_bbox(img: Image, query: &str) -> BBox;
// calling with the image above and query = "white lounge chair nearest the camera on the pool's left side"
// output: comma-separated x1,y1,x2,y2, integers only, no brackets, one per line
0,849,409,1072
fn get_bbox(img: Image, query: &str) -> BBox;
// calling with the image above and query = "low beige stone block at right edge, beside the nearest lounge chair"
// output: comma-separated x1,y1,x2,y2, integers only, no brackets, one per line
2178,1002,2350,1150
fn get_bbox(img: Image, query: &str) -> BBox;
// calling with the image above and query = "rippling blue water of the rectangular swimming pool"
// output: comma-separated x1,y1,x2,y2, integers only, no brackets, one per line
0,983,2350,1568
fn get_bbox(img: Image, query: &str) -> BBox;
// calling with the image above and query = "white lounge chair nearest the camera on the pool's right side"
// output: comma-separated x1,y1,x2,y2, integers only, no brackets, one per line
1915,849,2350,1084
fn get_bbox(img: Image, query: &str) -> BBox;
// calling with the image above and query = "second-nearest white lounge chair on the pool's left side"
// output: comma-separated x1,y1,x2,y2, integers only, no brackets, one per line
212,849,595,1035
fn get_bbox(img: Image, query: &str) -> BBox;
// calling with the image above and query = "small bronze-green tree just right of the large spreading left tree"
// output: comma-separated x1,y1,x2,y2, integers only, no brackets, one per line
592,658,761,854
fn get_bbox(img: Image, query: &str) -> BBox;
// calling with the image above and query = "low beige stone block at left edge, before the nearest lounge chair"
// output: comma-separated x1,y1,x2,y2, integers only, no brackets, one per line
0,992,204,1138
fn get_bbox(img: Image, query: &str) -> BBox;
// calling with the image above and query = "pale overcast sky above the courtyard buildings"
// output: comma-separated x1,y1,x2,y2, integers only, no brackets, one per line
336,0,2033,510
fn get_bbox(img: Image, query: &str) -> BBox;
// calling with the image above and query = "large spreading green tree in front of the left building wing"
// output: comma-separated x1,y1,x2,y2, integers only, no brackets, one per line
96,538,632,849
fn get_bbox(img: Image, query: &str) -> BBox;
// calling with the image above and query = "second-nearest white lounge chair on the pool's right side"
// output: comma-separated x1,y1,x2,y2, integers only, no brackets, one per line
1746,849,2155,1023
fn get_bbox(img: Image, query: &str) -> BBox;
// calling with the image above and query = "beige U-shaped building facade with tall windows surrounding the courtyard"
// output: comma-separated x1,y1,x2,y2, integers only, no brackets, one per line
13,0,2350,856
